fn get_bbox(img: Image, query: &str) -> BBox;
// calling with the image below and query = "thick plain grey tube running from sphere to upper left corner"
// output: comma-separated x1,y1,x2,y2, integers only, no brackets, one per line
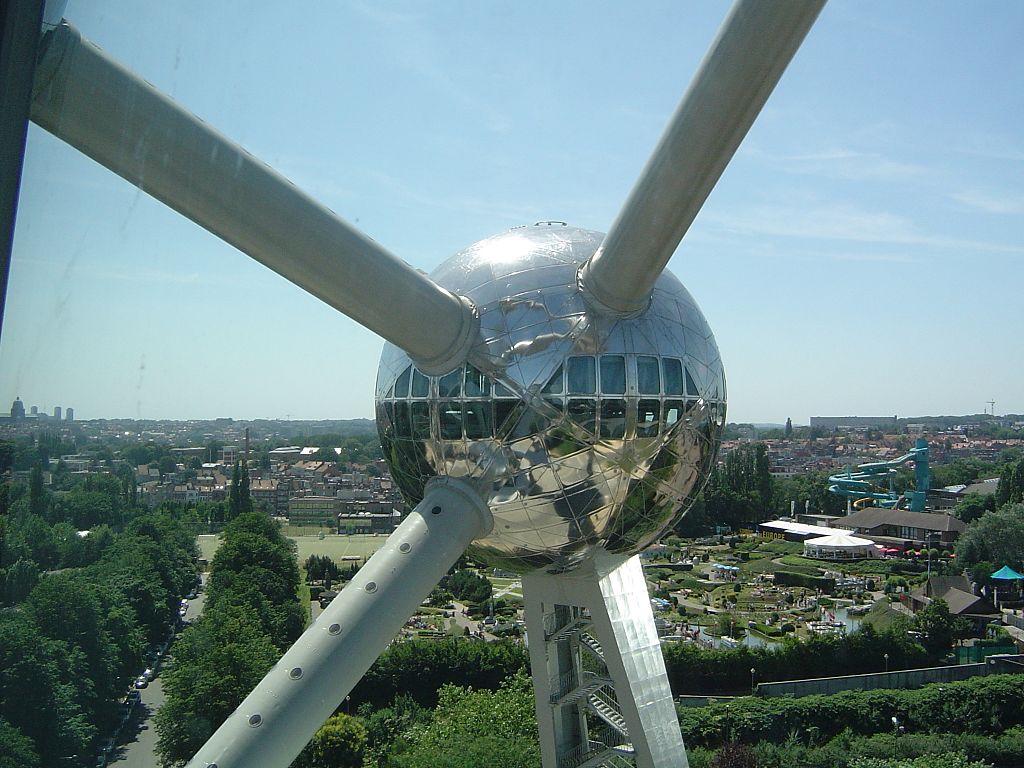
32,24,478,374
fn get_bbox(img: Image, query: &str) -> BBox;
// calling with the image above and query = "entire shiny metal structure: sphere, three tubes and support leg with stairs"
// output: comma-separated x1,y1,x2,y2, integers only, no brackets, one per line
6,0,831,768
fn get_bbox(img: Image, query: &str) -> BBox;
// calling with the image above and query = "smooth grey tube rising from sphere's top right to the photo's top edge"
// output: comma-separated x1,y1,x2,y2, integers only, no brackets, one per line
580,0,824,315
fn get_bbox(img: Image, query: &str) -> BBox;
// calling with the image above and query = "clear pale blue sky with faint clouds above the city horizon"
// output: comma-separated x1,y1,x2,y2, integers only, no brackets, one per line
0,0,1024,423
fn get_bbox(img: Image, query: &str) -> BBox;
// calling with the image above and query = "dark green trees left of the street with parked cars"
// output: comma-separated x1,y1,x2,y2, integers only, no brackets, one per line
0,501,196,766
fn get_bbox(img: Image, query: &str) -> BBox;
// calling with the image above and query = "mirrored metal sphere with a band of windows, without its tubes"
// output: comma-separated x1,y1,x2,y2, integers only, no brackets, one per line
376,224,726,573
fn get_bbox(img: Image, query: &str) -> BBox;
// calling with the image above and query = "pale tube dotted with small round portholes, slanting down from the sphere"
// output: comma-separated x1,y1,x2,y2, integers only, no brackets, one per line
188,478,493,768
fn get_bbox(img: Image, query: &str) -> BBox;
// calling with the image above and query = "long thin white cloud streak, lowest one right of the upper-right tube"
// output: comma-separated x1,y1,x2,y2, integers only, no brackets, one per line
709,205,1024,254
